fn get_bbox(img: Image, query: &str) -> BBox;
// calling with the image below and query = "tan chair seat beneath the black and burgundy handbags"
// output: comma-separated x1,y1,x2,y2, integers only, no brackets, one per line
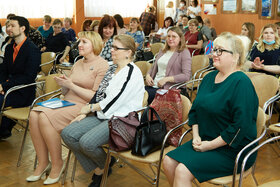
117,146,176,163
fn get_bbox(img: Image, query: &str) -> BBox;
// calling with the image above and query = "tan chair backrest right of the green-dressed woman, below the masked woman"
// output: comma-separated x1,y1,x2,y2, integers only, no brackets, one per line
246,72,279,107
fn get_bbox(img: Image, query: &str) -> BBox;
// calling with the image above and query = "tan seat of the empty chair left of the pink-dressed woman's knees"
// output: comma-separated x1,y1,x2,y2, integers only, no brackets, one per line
3,107,30,120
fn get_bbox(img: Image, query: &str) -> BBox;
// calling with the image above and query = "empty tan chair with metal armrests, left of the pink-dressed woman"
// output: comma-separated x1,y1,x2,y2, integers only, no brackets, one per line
0,74,60,167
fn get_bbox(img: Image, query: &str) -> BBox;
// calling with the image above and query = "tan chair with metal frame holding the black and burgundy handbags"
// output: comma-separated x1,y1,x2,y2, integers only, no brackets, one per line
101,95,191,187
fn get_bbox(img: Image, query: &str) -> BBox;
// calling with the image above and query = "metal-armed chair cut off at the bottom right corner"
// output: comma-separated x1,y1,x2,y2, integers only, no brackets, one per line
237,136,280,187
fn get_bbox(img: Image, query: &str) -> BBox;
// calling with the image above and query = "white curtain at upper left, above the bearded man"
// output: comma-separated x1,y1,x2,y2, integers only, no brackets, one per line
0,0,74,18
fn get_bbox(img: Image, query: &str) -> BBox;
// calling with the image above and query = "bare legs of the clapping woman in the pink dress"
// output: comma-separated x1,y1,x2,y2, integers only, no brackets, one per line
29,111,63,178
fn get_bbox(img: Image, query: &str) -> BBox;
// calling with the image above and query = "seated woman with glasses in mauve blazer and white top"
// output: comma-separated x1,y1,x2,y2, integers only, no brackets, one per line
145,27,192,104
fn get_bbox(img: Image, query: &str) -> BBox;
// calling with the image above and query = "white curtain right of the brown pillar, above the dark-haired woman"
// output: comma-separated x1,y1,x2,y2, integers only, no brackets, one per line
84,0,152,17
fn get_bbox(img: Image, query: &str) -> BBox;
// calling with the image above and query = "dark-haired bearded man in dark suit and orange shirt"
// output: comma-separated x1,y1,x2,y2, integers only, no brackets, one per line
0,16,41,139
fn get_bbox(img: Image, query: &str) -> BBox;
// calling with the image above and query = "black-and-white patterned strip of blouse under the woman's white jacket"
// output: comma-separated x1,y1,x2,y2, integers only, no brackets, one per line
90,64,118,103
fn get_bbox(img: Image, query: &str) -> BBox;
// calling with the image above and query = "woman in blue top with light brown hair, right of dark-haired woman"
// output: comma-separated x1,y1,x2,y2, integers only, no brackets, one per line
125,18,145,50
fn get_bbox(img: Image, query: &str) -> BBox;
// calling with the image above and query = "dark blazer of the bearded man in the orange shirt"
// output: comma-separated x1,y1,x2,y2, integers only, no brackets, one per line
0,38,41,107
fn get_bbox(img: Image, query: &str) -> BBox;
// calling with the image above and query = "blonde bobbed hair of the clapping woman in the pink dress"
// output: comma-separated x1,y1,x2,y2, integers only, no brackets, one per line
78,31,103,56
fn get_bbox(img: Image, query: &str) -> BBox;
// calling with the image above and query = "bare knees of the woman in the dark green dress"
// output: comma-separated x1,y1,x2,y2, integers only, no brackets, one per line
163,156,194,187
